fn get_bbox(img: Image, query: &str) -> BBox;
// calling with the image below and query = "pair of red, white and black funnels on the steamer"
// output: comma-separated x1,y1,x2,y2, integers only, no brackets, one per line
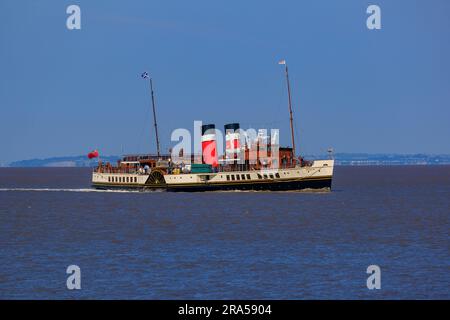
202,123,240,167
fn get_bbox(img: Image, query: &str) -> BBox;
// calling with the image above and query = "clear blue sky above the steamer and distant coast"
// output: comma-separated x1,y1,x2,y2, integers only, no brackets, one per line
0,0,450,163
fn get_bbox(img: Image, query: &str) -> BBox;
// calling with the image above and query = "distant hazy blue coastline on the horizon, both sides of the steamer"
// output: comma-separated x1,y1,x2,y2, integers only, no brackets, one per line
3,153,450,168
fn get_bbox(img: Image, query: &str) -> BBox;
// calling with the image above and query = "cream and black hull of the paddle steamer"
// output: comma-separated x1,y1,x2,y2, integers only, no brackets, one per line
92,160,334,192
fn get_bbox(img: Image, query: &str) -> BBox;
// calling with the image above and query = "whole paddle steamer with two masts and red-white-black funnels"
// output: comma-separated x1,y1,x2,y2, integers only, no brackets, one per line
92,60,334,192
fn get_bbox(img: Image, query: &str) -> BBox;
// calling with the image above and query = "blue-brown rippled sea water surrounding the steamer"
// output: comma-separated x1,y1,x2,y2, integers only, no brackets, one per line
0,166,450,299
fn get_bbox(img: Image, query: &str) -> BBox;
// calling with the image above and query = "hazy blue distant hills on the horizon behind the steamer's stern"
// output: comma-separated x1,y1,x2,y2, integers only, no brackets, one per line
8,155,120,167
